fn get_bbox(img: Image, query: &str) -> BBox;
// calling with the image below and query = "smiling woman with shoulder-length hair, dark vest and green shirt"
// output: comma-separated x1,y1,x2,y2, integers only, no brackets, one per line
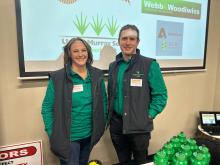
42,38,107,165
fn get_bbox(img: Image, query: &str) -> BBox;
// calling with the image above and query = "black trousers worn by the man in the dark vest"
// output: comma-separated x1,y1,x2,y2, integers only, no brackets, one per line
110,112,150,165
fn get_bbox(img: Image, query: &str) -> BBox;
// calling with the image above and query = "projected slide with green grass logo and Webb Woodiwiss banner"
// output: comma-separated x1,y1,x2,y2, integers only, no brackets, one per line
16,0,208,76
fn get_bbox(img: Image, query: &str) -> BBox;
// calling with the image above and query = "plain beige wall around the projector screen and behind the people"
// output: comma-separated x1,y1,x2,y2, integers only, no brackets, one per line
0,0,220,165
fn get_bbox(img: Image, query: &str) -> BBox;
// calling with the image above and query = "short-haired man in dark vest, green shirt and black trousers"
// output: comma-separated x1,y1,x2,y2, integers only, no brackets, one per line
108,25,167,165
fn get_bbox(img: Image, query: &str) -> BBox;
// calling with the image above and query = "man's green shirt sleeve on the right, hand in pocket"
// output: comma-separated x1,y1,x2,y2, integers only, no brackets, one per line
148,61,167,118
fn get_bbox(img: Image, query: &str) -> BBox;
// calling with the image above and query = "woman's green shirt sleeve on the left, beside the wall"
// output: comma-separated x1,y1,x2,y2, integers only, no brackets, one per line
41,79,55,137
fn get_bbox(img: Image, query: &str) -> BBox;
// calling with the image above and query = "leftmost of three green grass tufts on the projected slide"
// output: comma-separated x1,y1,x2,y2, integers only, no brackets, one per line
73,13,89,35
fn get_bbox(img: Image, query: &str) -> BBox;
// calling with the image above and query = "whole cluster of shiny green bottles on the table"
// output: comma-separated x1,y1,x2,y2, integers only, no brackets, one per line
154,132,211,165
